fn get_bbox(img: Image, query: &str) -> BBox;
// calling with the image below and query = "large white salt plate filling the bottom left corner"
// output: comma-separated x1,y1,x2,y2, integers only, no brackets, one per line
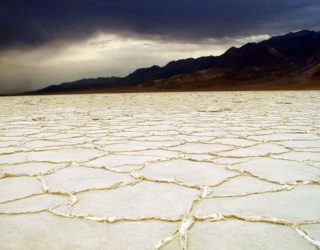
0,213,175,250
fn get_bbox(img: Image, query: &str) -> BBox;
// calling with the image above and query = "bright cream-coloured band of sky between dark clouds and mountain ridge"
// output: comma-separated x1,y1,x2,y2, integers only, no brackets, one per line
0,33,270,93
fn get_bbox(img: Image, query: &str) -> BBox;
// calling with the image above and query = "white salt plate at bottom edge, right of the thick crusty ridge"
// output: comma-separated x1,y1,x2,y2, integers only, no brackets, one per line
189,220,314,250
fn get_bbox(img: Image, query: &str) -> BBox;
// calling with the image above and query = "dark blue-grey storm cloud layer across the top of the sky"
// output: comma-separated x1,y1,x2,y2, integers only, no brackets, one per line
0,0,320,49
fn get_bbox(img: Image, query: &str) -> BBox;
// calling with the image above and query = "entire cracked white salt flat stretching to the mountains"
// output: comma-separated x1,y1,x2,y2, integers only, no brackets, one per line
0,92,320,250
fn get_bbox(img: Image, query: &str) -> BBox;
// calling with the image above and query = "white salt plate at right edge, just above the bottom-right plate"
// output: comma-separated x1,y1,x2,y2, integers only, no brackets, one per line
196,185,320,222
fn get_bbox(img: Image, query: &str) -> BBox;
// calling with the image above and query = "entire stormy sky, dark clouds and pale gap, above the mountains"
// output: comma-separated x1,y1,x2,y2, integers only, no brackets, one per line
0,0,320,94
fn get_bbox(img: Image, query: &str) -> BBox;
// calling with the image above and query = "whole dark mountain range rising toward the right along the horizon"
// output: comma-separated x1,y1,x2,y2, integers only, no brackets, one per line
27,30,320,94
